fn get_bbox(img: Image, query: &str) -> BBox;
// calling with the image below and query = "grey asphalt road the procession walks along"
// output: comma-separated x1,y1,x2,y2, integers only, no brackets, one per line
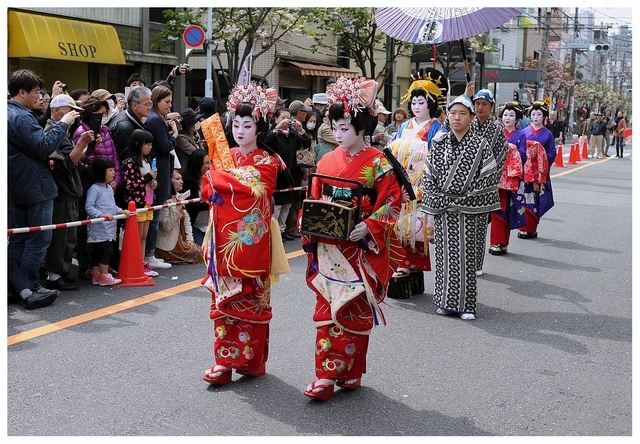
7,145,632,436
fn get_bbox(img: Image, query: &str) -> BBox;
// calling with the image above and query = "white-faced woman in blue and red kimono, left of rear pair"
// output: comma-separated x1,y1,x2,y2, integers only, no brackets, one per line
489,101,527,256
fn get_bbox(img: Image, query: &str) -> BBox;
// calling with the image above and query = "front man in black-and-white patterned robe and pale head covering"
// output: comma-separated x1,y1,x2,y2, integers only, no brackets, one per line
421,95,500,319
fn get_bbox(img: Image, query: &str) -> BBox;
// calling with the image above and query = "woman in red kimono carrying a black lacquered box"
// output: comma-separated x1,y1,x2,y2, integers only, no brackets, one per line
302,77,402,401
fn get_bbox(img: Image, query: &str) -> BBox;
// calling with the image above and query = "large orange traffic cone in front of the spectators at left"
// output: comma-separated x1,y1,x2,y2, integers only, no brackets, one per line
118,201,156,287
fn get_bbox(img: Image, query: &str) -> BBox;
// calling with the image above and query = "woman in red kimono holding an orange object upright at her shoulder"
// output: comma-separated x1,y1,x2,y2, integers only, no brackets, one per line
201,84,284,385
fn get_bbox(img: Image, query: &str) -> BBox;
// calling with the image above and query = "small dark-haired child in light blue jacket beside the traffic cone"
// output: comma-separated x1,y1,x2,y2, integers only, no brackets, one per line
85,157,129,287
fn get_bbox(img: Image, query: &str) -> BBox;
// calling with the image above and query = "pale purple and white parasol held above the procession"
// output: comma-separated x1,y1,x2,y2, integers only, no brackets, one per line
376,8,522,81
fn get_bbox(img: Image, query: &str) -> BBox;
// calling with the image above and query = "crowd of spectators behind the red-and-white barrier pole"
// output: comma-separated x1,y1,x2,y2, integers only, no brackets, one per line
8,69,407,309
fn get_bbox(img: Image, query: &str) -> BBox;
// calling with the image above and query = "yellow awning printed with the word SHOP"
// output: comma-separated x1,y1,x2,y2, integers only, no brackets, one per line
9,11,126,65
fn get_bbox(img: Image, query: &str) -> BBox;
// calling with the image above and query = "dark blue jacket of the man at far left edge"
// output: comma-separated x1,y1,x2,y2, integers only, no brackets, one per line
7,100,69,205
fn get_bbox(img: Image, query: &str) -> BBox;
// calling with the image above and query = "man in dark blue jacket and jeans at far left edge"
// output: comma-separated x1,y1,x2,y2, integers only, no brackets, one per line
7,69,79,309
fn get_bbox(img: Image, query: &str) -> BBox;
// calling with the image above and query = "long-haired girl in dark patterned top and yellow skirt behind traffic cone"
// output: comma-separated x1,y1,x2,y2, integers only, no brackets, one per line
122,129,158,277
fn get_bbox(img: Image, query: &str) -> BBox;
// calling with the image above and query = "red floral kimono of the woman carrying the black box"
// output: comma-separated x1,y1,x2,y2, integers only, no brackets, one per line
303,147,402,380
